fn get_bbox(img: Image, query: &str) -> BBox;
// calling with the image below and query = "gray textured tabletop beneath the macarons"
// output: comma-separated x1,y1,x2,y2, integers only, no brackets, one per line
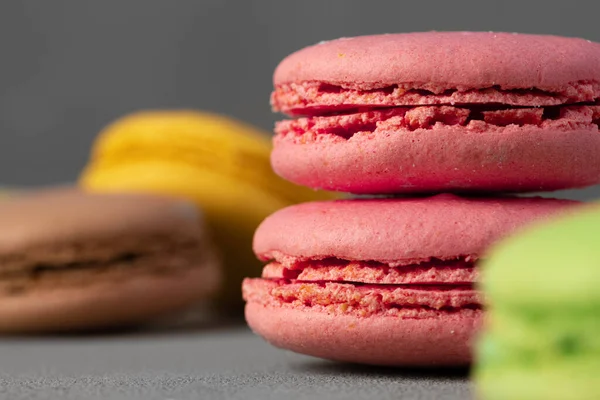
0,327,469,400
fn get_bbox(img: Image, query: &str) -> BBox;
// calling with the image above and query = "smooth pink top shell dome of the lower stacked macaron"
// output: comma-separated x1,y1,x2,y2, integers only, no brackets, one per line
253,194,578,266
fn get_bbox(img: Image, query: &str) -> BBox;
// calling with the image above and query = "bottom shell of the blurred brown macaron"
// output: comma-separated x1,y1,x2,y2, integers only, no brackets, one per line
0,248,220,334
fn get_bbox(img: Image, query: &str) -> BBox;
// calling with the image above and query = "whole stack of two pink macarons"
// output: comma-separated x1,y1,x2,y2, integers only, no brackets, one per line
243,32,600,365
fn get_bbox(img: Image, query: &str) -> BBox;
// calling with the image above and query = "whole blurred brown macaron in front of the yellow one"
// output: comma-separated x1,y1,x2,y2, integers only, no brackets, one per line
0,189,221,333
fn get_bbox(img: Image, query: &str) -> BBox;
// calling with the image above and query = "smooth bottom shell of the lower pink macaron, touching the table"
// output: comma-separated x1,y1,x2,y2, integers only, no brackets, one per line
246,302,480,366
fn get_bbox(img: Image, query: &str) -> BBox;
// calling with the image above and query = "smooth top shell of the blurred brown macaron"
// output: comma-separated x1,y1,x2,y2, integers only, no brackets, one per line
0,186,204,256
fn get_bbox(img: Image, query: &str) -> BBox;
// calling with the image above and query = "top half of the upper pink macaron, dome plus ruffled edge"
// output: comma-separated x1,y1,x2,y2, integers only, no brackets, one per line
271,32,600,114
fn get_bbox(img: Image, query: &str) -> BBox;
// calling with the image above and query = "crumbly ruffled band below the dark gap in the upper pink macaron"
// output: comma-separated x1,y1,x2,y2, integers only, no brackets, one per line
275,105,600,143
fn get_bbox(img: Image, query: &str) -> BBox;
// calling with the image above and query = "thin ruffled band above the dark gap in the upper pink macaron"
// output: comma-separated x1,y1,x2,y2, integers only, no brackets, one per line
271,80,600,115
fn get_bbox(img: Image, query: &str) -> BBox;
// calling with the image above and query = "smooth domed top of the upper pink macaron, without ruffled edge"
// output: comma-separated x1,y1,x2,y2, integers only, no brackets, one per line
273,32,600,90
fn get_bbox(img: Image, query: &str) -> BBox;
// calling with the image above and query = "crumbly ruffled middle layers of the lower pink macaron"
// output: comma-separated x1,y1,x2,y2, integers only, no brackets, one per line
243,257,482,318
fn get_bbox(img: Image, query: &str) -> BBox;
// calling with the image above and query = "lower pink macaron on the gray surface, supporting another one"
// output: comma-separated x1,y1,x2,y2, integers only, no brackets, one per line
243,194,577,365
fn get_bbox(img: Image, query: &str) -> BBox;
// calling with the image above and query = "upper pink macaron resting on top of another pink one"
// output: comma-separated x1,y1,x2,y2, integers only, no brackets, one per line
271,32,600,194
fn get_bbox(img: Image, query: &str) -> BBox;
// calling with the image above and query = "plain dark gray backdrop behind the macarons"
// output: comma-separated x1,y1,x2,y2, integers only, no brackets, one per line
0,0,600,198
